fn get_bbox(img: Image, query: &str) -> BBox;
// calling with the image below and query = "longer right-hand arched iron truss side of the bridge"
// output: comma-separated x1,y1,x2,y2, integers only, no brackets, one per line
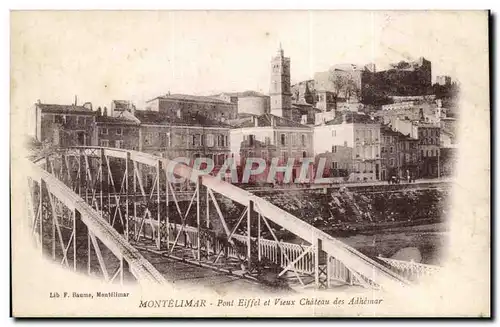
34,147,408,287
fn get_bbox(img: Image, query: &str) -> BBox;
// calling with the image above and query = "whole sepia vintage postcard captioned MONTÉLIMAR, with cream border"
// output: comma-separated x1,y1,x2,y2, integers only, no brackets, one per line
10,10,491,317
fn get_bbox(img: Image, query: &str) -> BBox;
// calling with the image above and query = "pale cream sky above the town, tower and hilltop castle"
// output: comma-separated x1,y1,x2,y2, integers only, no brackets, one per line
11,11,487,108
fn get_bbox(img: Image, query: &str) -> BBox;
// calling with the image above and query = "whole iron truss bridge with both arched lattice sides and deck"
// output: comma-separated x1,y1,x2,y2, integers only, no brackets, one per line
25,147,418,289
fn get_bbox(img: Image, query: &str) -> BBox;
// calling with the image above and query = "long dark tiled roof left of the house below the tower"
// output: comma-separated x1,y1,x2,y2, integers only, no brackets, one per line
135,110,230,128
